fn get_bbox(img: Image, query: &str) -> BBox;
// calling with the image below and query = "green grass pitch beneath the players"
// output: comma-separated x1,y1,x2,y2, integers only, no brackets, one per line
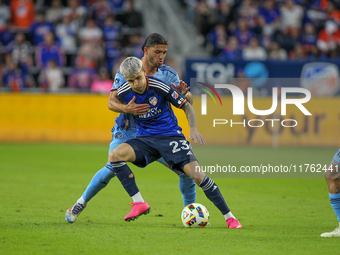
0,143,340,255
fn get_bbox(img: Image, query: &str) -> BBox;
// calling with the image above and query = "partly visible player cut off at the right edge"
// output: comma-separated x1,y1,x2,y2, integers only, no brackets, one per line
321,149,340,237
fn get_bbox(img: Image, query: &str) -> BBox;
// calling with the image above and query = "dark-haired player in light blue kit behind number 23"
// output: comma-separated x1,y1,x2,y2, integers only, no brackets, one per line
65,33,196,223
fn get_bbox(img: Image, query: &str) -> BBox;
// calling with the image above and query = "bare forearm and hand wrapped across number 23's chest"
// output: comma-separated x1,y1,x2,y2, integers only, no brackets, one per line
108,91,150,114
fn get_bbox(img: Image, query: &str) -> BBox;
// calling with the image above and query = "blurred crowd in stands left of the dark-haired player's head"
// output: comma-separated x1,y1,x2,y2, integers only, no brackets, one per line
0,0,143,93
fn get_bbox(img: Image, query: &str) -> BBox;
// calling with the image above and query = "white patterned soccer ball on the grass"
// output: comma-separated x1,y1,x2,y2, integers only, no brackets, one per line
181,203,209,228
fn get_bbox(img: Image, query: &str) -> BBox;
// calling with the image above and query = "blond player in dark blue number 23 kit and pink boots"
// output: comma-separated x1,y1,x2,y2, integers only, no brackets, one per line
108,57,242,228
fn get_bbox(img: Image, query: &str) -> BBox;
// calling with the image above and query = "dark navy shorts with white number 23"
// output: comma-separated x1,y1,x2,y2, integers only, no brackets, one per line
125,135,197,172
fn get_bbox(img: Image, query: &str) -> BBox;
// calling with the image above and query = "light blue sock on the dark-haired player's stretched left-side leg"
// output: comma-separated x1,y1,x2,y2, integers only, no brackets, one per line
83,163,116,202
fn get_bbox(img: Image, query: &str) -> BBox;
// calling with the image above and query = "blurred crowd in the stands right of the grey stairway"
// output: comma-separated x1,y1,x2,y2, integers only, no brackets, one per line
179,0,340,60
